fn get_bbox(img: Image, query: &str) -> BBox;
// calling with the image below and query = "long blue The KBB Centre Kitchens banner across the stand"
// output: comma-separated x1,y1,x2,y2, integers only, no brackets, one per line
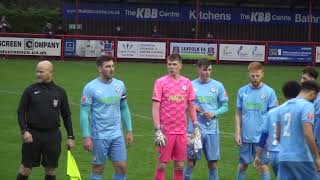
63,2,320,25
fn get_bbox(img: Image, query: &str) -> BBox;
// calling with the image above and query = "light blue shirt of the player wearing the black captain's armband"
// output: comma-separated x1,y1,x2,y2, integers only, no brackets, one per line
81,78,126,139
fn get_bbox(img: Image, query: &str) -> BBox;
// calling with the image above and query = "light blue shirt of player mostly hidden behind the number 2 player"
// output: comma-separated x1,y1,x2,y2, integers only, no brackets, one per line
262,106,281,152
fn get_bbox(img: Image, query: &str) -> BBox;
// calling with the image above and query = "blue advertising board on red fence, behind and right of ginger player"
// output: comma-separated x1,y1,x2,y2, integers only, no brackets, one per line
268,45,312,63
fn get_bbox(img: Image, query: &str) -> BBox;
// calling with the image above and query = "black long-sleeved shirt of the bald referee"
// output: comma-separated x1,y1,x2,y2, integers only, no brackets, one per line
18,81,73,138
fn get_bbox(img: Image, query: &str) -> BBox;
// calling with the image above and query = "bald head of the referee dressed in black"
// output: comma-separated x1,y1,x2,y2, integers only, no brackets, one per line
36,60,53,83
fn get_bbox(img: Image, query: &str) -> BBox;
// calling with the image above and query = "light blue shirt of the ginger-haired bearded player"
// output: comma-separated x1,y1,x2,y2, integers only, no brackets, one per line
237,84,278,143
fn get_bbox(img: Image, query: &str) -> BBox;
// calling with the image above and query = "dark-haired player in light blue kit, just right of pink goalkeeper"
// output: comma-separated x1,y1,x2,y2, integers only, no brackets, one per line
184,59,228,180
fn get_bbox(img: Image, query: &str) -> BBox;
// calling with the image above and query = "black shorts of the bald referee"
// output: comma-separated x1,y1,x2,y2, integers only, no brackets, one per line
21,129,62,168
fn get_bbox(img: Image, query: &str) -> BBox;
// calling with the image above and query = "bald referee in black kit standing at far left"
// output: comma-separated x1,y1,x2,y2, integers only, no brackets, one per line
17,61,74,180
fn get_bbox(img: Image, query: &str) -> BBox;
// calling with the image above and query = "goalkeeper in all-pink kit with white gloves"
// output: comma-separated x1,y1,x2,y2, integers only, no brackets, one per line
152,54,200,180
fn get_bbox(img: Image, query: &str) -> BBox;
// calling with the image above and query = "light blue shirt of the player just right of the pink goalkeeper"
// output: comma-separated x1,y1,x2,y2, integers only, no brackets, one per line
188,79,228,134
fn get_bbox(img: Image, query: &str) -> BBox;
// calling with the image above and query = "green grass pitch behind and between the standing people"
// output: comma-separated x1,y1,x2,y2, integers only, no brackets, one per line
0,60,316,180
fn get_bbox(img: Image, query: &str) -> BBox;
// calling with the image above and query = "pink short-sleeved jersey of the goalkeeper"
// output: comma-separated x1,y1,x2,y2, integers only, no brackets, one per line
152,75,195,134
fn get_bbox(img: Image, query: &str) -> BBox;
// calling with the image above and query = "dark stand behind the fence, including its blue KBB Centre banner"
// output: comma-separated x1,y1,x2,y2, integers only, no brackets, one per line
61,0,320,41
